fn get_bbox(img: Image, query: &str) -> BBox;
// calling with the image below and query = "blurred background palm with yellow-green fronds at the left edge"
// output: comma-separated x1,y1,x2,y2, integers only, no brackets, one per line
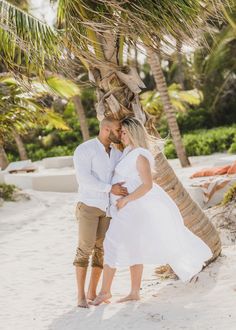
0,73,69,162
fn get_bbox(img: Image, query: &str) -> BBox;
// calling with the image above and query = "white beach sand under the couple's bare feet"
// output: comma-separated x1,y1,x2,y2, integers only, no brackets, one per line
0,191,236,330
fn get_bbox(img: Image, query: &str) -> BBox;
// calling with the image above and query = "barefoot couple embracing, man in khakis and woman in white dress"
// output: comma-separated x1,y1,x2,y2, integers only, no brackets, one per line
74,117,212,308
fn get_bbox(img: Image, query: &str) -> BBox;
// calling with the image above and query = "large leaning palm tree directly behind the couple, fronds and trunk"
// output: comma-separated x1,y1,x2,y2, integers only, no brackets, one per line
0,0,221,258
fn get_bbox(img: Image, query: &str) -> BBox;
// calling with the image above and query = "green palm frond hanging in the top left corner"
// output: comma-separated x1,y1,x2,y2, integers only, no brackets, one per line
0,0,63,75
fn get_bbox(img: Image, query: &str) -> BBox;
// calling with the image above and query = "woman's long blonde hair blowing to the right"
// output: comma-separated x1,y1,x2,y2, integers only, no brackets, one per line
121,117,165,155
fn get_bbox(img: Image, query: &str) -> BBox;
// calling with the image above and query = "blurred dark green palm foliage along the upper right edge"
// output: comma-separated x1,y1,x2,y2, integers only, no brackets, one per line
200,2,236,118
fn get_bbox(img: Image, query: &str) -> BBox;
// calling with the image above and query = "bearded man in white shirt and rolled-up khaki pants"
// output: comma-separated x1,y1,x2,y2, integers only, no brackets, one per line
73,118,128,308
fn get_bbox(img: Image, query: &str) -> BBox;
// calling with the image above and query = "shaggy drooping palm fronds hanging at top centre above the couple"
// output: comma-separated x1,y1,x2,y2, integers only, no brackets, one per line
61,0,227,57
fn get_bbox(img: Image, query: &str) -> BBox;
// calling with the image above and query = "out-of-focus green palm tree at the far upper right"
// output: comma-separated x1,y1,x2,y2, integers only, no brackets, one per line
193,1,236,126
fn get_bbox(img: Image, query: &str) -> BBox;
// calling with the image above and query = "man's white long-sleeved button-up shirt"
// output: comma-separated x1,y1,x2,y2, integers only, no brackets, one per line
73,138,122,215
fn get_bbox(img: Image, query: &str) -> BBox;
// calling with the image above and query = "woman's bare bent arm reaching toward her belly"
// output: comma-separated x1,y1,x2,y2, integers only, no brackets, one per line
116,155,153,209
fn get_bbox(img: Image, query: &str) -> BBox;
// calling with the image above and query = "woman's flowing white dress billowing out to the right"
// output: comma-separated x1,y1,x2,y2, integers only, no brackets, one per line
104,147,212,281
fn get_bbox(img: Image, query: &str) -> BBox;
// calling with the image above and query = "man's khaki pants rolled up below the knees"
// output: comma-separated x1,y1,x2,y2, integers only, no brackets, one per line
73,202,110,268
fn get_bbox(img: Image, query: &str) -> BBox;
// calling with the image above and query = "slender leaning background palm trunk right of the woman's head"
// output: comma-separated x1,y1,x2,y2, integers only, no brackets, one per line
146,47,190,167
